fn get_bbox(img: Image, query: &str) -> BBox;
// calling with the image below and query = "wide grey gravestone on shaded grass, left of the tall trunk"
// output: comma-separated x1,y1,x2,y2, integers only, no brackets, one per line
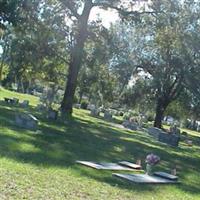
15,113,38,131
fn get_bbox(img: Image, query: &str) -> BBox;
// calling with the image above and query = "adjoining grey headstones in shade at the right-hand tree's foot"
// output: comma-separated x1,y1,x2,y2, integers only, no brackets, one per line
147,127,180,147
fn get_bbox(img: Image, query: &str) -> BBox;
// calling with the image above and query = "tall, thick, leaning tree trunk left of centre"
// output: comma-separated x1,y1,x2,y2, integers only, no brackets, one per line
61,1,92,116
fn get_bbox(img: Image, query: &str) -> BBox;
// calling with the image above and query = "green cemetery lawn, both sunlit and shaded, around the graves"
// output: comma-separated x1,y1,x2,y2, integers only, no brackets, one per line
0,89,200,200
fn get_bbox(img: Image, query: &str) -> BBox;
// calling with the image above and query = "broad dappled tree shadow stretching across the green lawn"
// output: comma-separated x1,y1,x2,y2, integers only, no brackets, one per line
0,103,200,194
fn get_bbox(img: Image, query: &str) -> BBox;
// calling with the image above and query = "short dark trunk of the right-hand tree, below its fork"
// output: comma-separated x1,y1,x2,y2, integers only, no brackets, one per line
154,99,169,128
